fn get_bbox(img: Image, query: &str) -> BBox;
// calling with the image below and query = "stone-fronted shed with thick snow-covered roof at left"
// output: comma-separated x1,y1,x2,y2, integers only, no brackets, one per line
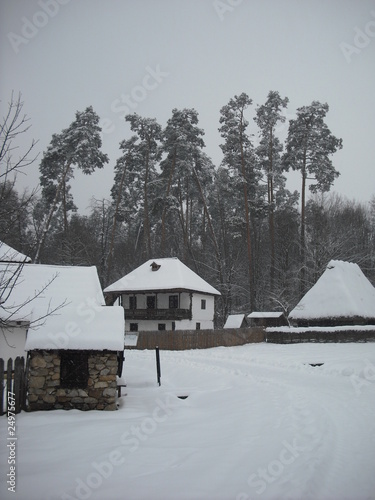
1,258,124,410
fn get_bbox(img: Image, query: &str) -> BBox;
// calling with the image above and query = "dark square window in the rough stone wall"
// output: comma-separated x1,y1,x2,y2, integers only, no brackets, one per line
60,351,89,389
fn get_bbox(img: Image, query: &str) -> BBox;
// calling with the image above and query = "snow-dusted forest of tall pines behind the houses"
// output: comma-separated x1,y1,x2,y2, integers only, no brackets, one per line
0,91,375,325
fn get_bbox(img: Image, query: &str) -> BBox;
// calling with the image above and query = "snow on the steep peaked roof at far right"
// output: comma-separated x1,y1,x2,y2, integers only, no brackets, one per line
289,260,375,319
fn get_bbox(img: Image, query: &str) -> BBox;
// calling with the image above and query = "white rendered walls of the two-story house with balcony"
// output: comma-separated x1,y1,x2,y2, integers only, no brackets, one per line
123,292,215,331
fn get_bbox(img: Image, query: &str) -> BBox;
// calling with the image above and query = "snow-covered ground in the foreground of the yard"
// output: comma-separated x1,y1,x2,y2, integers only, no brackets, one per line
0,343,375,500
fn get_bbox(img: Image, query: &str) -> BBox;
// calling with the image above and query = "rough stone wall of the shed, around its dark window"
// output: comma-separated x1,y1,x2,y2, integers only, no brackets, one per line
27,351,118,411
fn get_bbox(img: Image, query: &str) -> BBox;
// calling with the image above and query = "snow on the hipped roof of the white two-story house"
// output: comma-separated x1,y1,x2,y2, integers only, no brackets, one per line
104,257,221,295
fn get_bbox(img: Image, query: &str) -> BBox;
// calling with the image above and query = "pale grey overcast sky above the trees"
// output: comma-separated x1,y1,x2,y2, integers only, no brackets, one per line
0,0,375,211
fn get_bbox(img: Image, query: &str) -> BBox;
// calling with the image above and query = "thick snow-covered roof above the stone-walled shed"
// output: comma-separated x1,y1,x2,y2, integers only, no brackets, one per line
0,264,124,350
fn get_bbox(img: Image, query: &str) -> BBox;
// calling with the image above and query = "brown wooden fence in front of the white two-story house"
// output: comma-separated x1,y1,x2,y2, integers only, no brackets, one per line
126,328,265,351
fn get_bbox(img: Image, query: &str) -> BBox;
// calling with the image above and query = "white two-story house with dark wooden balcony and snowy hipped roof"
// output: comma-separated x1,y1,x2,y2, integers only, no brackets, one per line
104,258,220,332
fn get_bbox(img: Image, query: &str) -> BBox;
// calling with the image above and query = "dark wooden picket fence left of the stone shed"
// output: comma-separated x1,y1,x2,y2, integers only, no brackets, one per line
0,357,27,415
